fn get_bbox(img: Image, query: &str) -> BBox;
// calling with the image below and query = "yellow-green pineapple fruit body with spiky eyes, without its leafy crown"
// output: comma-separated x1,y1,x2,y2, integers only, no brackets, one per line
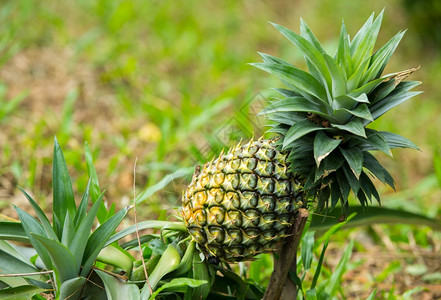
182,140,304,261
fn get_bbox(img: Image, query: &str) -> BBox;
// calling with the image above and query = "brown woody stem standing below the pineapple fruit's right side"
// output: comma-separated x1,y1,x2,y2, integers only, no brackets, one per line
262,208,309,300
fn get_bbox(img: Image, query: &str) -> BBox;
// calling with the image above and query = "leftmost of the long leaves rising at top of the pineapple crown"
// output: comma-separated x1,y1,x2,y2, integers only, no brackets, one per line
272,23,332,88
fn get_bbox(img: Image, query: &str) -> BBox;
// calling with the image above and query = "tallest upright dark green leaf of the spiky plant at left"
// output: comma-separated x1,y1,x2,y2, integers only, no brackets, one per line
52,138,76,237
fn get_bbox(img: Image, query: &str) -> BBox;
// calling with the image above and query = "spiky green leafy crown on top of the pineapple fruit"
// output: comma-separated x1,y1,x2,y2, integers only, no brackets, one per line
252,12,420,209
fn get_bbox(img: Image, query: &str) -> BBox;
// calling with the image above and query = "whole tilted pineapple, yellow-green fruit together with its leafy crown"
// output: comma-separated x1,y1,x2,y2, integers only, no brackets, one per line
182,13,420,262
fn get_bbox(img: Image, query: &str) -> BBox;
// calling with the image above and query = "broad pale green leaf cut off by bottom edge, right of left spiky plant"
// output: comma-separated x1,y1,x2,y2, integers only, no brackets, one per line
95,270,141,300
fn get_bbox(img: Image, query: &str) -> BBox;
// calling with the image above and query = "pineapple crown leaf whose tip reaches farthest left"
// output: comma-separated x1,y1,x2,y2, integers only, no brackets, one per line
251,63,327,103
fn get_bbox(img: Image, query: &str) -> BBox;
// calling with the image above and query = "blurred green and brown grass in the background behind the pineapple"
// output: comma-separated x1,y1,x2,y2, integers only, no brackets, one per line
0,0,441,298
